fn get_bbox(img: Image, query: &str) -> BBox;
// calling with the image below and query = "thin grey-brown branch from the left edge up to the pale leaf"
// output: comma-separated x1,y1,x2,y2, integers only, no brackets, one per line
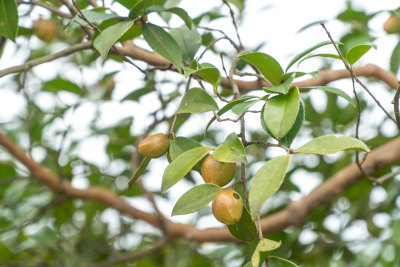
0,42,93,78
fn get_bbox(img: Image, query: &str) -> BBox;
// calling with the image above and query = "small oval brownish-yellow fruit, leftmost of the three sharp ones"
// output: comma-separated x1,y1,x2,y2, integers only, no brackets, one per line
138,133,169,158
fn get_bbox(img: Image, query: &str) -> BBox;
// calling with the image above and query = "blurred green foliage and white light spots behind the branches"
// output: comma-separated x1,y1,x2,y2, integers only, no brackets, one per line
0,0,400,267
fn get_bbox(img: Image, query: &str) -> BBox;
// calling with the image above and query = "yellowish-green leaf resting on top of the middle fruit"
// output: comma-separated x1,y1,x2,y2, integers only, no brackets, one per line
213,133,247,163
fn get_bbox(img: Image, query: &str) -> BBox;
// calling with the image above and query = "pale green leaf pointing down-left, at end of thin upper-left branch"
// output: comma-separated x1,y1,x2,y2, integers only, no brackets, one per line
93,21,133,59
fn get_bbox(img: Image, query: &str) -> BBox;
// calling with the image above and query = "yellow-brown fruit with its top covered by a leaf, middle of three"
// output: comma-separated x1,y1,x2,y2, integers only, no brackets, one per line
201,155,236,186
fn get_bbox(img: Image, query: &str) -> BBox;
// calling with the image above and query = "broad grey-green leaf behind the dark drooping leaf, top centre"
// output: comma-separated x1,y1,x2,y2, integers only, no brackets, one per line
169,27,201,63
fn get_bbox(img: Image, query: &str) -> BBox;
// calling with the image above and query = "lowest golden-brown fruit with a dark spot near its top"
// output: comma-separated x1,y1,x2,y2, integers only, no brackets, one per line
212,188,243,225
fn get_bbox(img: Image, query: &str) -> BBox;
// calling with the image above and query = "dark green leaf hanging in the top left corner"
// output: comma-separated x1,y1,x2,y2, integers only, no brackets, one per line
0,0,19,42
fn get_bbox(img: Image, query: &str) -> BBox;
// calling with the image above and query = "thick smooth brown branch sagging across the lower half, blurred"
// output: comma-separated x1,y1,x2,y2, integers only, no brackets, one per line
0,132,400,242
